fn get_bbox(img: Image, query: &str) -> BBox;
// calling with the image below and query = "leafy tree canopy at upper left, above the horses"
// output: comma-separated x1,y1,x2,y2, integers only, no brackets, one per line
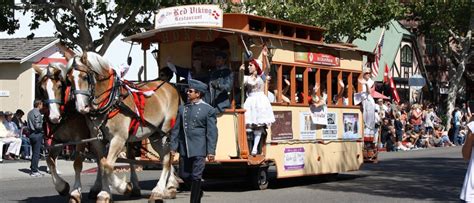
12,0,170,55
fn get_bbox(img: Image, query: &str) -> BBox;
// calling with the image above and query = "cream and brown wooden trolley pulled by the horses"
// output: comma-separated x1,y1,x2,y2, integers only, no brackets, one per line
125,5,371,189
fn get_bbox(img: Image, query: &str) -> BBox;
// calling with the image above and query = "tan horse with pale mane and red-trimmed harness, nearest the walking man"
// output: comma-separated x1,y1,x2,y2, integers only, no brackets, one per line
67,52,181,202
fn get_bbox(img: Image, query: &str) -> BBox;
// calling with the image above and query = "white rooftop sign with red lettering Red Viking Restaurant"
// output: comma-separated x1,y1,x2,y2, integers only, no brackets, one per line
155,5,224,29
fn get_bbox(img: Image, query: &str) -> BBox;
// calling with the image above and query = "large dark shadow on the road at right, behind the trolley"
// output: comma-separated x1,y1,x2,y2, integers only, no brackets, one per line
307,157,467,201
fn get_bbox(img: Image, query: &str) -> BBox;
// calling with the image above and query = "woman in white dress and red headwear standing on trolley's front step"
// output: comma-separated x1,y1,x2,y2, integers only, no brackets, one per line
240,59,275,155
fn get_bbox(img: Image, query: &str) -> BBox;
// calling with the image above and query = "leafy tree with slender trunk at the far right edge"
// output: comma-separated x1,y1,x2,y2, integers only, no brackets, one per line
407,1,474,127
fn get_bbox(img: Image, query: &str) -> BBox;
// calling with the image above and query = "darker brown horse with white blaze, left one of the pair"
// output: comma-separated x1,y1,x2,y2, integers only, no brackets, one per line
33,63,140,202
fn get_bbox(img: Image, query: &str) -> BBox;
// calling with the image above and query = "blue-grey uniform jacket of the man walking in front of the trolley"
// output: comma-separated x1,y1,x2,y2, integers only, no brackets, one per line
171,102,217,158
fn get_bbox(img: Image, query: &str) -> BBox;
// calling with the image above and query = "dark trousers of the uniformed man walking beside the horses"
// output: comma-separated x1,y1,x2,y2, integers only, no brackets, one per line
179,156,206,183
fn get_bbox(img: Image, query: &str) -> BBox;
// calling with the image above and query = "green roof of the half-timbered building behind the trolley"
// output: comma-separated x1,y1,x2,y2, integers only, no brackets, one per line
354,20,412,81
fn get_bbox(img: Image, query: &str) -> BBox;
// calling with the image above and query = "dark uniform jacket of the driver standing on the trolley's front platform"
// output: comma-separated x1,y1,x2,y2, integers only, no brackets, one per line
209,66,234,113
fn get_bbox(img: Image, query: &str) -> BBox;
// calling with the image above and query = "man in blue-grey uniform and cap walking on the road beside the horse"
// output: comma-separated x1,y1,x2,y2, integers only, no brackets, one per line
171,79,217,202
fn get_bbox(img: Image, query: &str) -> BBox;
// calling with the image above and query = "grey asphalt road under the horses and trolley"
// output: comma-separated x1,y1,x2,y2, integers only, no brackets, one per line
0,147,467,203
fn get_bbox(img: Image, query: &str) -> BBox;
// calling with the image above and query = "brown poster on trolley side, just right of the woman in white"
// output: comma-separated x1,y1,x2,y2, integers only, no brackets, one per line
271,111,293,140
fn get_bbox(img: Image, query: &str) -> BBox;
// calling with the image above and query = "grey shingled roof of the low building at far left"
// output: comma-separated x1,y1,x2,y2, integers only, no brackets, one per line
0,37,59,61
